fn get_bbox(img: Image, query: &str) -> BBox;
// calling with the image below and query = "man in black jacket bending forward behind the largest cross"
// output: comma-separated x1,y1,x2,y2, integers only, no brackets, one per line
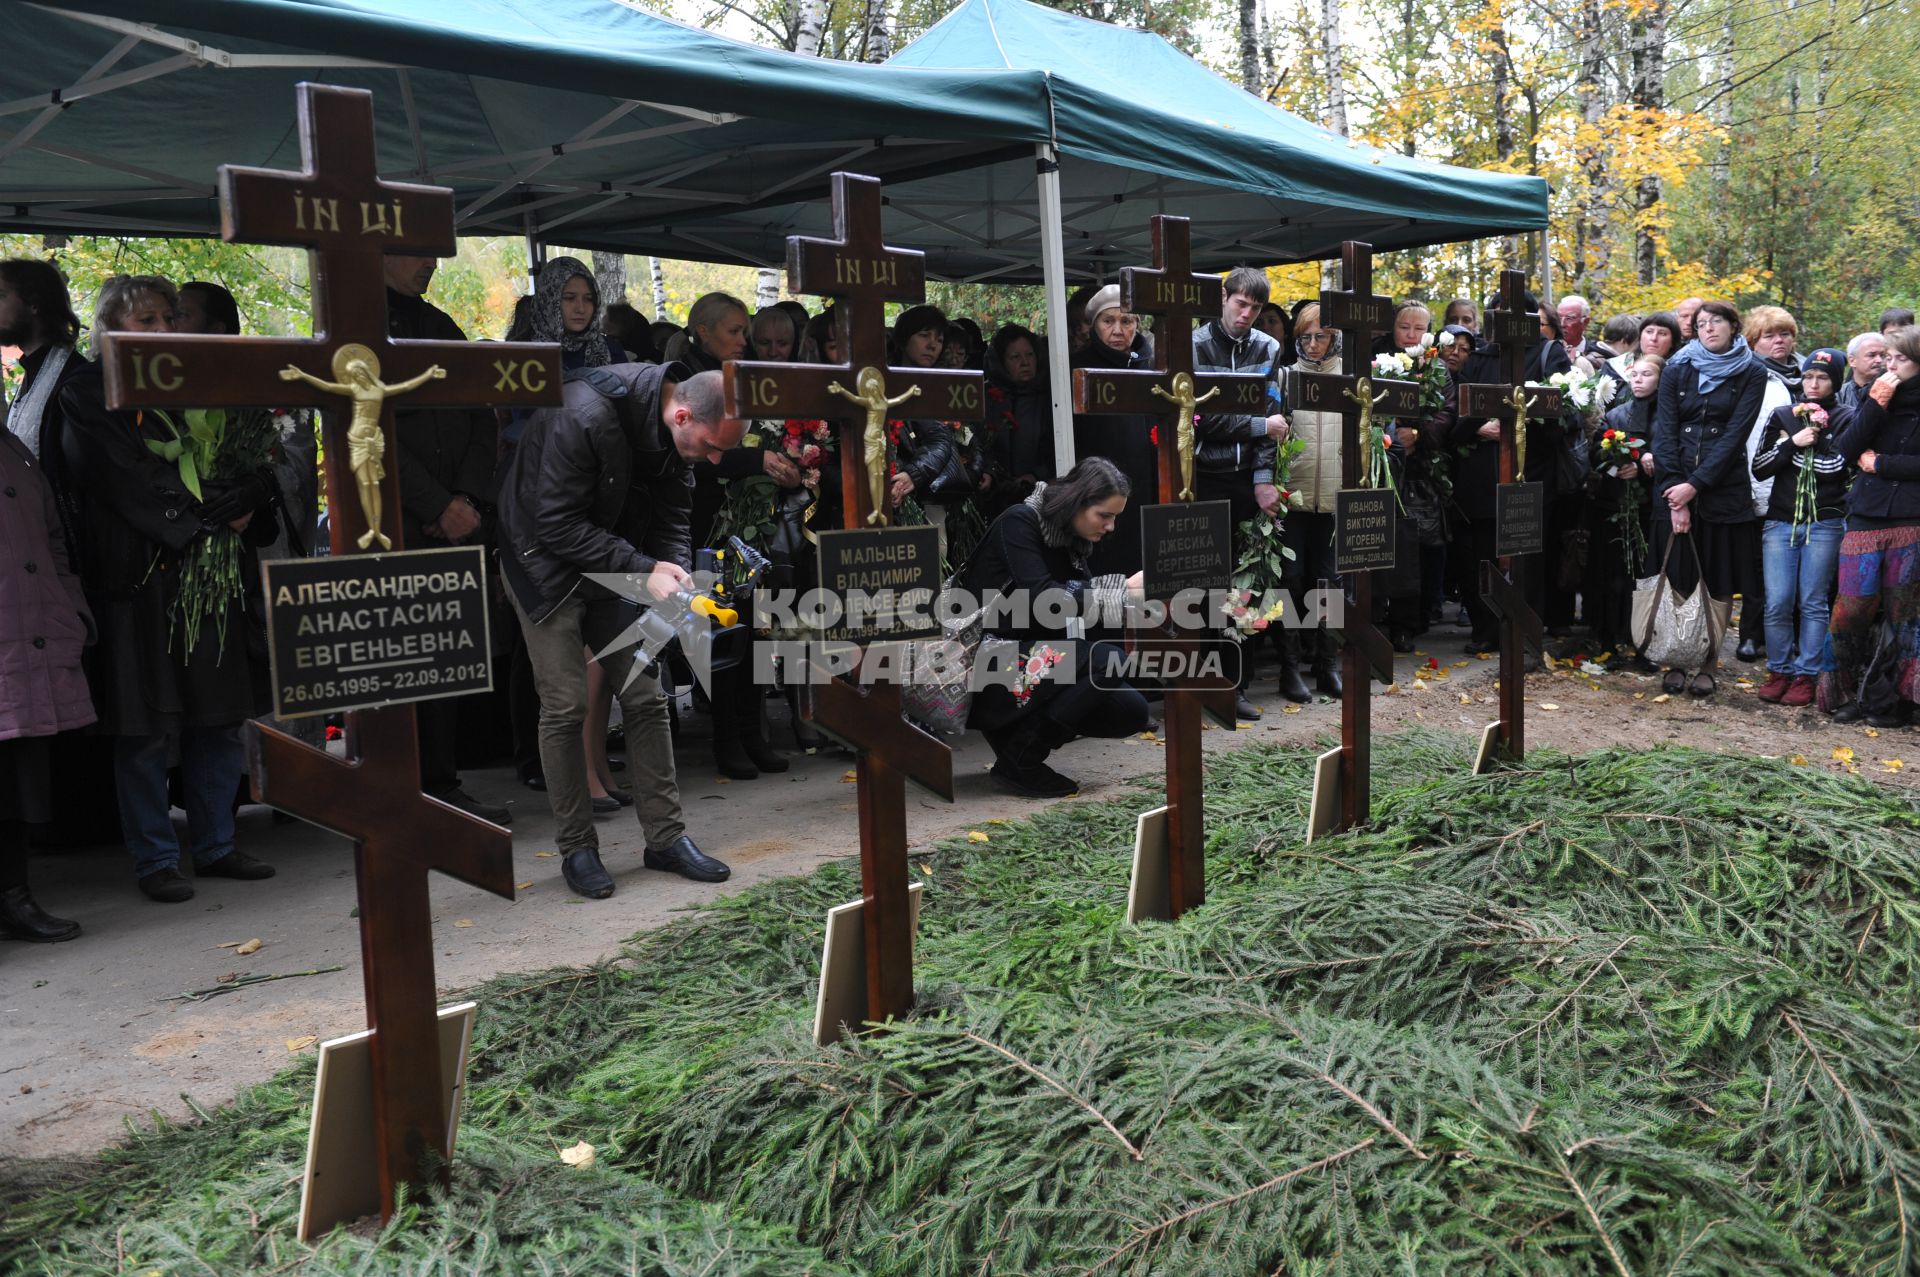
499,363,745,901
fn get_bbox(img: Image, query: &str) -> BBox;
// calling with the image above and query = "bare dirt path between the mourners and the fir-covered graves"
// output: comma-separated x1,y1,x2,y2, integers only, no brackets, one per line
0,624,1920,1156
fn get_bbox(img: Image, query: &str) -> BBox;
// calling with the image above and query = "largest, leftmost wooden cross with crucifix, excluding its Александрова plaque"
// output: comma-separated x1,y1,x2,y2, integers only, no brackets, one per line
102,84,561,1216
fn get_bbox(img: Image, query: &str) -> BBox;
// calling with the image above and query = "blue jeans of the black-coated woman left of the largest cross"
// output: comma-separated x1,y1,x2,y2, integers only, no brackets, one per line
113,724,246,878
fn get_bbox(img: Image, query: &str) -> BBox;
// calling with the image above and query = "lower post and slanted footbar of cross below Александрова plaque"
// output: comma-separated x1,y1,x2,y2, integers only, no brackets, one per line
246,705,513,1214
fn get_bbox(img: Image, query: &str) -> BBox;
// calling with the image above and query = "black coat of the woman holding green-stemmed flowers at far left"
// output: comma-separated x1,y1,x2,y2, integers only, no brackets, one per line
53,363,276,735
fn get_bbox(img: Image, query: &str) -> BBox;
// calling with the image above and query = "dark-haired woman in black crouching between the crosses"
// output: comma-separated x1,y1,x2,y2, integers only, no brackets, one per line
960,457,1146,799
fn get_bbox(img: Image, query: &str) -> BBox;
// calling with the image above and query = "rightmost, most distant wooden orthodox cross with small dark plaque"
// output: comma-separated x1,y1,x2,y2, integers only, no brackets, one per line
1459,271,1561,772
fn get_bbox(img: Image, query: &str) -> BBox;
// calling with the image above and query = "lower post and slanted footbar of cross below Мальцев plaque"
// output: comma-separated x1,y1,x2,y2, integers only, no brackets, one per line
801,678,954,1024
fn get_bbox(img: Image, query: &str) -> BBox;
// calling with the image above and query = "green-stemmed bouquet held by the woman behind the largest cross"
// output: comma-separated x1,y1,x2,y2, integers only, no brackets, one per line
134,407,280,653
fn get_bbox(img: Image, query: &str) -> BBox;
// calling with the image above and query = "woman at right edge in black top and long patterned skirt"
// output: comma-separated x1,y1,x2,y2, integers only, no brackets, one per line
1812,321,1920,728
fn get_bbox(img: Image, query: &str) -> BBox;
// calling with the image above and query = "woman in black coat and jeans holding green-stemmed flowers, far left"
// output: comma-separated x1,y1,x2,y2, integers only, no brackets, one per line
60,275,275,903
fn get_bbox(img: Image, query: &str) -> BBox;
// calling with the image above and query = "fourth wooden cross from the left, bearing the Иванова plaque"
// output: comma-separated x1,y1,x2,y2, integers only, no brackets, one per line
1288,240,1421,839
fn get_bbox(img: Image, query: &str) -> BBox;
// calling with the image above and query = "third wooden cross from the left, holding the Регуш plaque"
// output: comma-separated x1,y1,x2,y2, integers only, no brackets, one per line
1073,215,1267,918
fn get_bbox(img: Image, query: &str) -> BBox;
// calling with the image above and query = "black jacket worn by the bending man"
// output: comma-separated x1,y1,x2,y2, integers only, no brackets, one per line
499,363,693,622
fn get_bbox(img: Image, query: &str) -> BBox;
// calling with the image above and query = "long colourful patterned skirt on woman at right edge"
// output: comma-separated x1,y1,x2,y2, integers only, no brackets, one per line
1818,526,1920,712
